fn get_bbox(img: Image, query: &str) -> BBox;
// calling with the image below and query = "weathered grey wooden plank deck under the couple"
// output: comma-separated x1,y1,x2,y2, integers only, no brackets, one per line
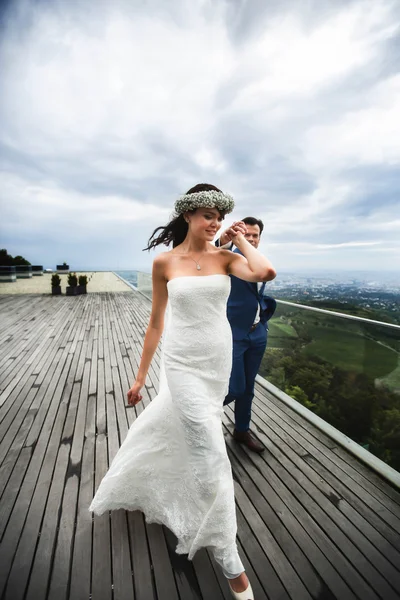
0,291,400,600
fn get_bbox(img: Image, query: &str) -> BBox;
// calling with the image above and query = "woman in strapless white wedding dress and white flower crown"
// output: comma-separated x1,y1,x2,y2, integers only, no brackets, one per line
89,184,275,600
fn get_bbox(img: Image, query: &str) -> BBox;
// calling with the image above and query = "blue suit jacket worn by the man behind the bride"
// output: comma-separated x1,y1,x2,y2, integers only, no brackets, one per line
223,248,276,340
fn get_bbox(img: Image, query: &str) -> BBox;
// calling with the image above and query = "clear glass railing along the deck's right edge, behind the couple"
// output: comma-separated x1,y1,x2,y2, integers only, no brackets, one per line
119,271,400,471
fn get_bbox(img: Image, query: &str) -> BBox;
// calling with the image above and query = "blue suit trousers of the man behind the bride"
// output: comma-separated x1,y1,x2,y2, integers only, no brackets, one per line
224,323,268,432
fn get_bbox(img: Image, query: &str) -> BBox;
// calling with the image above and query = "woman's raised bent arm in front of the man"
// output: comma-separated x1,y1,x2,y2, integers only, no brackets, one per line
228,233,276,281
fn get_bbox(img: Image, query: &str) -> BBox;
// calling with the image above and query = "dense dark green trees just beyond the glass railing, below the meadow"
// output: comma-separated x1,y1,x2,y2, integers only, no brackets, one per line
260,340,400,470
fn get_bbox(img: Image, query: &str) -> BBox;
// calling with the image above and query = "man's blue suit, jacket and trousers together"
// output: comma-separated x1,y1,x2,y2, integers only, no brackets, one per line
224,249,276,432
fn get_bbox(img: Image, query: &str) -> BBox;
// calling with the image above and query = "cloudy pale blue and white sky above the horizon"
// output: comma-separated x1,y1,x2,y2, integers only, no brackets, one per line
0,0,400,271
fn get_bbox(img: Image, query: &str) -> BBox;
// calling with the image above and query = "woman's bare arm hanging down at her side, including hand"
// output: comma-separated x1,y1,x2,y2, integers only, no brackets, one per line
128,255,168,406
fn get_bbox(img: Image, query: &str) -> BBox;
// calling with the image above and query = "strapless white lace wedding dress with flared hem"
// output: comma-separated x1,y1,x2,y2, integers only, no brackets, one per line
89,274,244,578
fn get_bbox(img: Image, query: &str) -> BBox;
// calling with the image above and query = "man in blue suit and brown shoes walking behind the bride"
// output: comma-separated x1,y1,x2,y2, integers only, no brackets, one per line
215,217,276,453
